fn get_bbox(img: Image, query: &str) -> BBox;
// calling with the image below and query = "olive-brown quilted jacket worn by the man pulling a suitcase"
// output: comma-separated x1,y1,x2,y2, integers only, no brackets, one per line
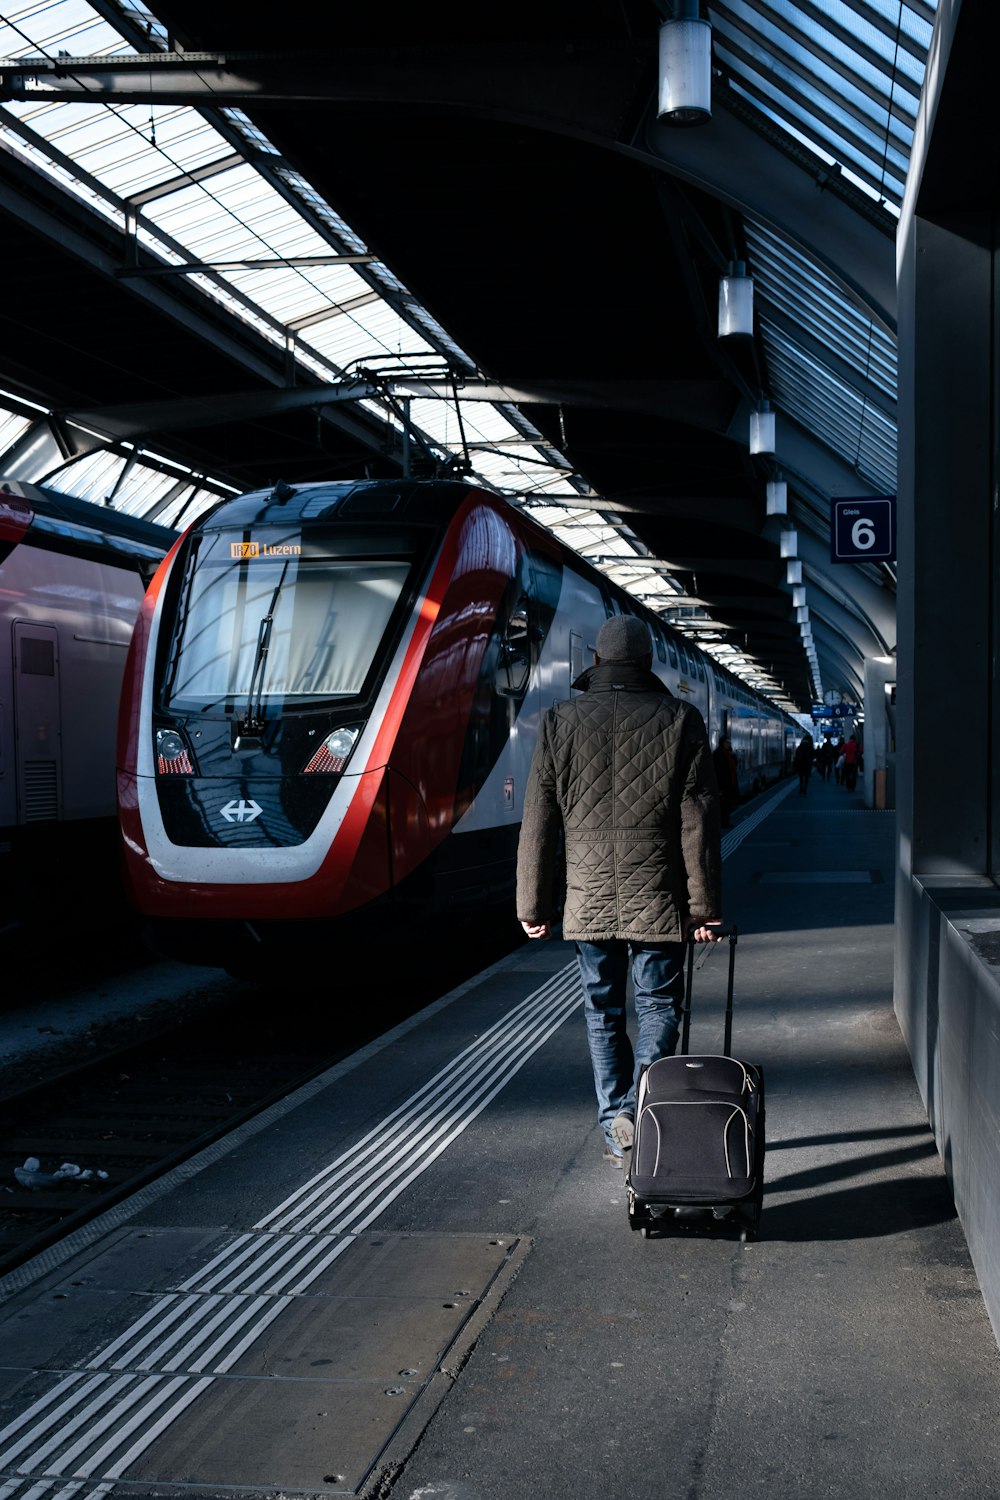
517,662,721,942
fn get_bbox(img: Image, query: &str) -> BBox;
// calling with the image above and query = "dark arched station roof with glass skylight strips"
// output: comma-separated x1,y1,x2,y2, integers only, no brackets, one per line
0,0,934,711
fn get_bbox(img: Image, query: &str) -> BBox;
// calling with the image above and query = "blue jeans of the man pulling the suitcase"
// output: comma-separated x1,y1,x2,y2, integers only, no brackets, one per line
576,938,687,1151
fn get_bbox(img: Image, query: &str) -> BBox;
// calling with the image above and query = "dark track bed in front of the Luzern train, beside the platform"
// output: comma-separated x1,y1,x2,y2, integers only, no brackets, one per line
0,906,527,1275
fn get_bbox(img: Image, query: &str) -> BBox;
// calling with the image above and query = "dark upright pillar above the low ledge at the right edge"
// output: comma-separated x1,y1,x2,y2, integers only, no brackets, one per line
897,212,994,876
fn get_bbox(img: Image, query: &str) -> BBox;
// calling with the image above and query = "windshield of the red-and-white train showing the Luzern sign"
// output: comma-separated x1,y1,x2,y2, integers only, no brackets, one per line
165,528,412,713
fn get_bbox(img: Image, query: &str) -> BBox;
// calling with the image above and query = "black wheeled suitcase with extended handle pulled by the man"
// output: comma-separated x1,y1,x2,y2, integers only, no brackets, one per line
625,927,765,1241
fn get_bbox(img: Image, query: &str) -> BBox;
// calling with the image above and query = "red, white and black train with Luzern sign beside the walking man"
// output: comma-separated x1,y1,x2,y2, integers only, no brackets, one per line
117,480,798,974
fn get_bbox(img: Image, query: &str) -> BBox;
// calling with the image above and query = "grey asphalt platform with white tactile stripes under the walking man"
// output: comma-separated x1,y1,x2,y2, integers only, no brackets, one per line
0,777,1000,1500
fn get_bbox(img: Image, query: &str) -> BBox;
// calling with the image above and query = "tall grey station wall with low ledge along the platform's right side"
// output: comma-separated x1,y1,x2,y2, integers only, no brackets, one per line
895,0,1000,1340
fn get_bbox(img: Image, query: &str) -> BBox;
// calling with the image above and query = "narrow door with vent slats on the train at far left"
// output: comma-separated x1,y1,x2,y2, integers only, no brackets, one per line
13,620,63,824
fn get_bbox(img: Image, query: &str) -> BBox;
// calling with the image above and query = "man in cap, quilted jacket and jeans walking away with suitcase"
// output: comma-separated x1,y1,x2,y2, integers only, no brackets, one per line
517,615,723,1167
